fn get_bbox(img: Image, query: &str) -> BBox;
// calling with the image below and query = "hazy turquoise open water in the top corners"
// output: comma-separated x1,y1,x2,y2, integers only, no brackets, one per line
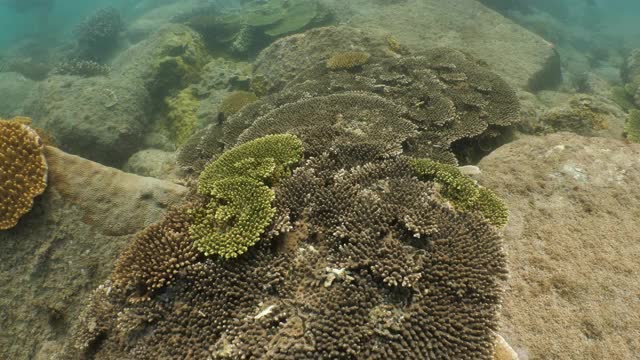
0,0,640,60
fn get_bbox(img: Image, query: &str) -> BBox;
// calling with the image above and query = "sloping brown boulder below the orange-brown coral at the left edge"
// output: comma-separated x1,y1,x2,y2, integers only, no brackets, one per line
0,147,186,360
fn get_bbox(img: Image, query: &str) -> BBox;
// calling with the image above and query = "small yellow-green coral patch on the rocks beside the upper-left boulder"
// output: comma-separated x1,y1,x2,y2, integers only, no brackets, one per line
165,88,198,146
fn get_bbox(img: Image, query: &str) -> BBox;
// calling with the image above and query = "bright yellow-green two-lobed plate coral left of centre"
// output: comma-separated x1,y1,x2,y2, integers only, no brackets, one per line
189,135,303,258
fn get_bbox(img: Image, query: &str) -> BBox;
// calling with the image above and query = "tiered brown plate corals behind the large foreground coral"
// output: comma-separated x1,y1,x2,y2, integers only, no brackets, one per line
222,39,520,163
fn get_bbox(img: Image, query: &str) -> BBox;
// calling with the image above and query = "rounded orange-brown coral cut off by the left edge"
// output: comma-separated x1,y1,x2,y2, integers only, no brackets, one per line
0,118,47,230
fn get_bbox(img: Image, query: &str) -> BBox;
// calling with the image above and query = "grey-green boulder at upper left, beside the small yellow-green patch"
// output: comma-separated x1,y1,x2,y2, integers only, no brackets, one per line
25,25,206,166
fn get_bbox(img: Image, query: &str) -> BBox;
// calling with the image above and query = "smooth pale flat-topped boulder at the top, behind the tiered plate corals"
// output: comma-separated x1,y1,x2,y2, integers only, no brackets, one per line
327,0,562,91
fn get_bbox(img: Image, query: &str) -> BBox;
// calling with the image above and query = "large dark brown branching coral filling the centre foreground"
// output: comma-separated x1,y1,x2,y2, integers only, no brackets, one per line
71,142,506,359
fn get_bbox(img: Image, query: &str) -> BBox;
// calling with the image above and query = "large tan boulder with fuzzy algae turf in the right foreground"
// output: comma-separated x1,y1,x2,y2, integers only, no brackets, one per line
478,133,640,360
